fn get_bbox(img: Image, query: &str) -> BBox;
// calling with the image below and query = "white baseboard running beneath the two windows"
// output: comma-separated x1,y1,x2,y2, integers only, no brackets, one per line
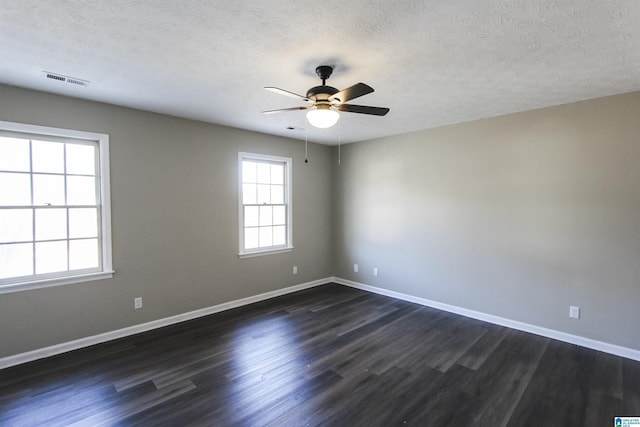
0,277,333,369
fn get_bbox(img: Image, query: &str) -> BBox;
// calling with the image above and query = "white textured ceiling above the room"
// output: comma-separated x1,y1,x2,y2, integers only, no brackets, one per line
0,0,640,145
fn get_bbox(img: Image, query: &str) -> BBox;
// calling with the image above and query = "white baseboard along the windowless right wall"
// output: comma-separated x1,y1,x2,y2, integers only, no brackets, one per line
333,277,640,361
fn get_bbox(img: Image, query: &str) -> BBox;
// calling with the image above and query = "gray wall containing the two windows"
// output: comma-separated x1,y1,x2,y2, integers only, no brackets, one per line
0,85,332,357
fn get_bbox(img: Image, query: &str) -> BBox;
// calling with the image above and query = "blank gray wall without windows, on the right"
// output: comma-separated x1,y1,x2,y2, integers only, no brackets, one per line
333,93,640,349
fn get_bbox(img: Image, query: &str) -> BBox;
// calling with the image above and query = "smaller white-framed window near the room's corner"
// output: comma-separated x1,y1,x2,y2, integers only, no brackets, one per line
238,153,293,257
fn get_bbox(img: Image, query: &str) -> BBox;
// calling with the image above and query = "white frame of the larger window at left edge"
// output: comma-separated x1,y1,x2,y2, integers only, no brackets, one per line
0,121,114,294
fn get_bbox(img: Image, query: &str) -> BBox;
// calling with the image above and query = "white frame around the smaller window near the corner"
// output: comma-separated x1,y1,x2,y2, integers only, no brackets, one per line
238,152,293,258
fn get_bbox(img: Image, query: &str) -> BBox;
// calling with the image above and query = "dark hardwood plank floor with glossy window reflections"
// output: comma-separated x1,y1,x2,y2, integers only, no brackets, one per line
0,284,640,427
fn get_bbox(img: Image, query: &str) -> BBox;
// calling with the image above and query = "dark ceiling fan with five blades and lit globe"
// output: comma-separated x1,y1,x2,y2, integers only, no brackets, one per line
262,65,389,128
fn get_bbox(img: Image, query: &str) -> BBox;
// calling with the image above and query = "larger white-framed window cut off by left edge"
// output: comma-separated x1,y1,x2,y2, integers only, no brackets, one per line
0,121,113,293
